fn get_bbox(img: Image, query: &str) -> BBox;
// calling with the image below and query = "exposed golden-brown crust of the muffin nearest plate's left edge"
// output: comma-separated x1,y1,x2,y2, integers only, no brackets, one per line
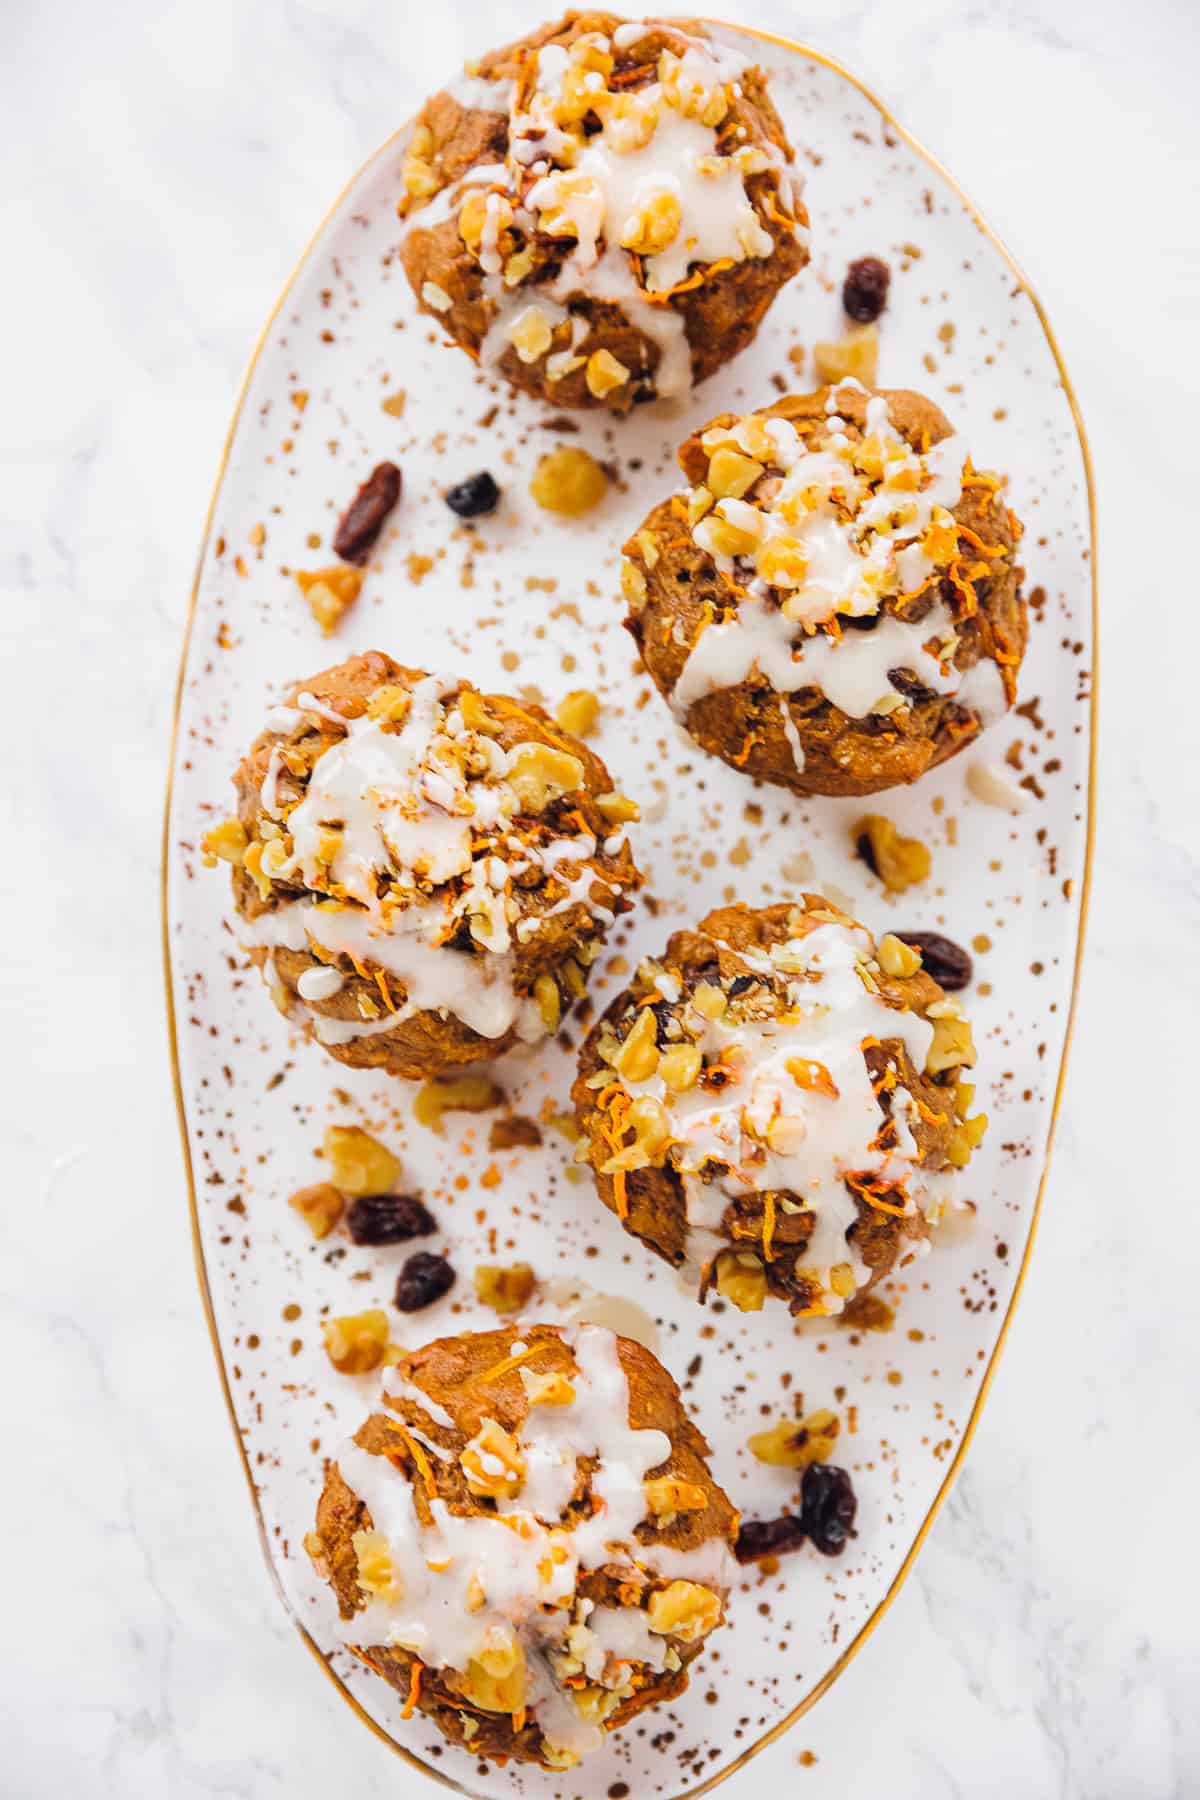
219,652,640,1078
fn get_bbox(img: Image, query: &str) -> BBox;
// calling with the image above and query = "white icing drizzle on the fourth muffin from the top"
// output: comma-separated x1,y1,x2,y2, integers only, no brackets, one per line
621,923,948,1312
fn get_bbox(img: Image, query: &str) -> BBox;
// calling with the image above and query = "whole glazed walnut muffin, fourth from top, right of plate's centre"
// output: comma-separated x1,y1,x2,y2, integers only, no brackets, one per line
572,895,988,1316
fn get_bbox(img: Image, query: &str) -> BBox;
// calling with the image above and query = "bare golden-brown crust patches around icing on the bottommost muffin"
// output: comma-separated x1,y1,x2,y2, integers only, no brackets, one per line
306,1325,738,1766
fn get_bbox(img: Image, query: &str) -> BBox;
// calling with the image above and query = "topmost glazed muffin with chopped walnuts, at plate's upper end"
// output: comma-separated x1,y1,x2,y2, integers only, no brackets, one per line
401,13,808,412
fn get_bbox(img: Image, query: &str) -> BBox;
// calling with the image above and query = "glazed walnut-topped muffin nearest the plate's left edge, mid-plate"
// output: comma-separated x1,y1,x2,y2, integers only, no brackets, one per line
205,652,640,1078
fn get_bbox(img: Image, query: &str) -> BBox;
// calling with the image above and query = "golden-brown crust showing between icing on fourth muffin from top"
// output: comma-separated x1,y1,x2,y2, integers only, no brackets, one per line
572,895,986,1314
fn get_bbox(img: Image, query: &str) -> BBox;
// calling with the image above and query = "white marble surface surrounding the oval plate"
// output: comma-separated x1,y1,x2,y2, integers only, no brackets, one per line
0,0,1200,1800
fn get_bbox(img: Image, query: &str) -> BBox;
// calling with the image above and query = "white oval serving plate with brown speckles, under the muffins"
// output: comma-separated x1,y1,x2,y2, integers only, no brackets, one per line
166,27,1094,1796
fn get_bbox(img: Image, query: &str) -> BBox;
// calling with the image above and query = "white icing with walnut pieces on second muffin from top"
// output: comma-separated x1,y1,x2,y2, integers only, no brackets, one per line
671,383,1007,727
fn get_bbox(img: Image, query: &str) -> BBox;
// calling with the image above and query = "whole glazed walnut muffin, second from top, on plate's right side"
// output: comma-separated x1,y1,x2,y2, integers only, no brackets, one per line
622,382,1027,794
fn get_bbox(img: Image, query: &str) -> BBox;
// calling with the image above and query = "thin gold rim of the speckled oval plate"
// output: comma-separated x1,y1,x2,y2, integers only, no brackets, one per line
160,28,1099,1800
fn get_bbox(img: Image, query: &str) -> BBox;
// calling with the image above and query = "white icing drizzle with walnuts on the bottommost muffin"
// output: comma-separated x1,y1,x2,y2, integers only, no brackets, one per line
336,1325,736,1755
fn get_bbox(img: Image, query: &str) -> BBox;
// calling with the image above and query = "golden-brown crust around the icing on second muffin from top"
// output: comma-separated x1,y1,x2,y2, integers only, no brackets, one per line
622,383,1027,796
